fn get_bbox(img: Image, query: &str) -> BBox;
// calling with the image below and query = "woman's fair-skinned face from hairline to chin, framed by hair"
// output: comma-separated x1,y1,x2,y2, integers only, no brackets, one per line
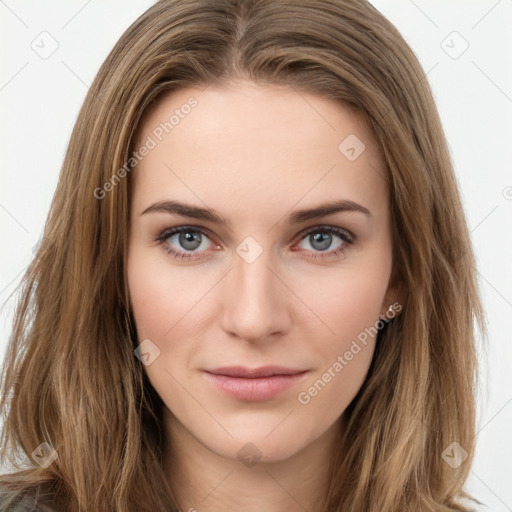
128,82,396,461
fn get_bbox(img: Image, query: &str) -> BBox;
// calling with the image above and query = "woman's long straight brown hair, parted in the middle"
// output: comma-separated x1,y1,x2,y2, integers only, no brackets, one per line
1,0,485,512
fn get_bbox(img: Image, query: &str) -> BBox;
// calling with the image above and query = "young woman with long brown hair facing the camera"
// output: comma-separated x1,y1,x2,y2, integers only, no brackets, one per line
1,0,484,512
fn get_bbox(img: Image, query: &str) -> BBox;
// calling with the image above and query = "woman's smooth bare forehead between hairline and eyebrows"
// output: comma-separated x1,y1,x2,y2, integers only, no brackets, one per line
132,81,386,218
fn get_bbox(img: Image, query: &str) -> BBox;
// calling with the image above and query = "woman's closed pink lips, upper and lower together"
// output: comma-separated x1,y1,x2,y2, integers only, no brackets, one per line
203,366,308,401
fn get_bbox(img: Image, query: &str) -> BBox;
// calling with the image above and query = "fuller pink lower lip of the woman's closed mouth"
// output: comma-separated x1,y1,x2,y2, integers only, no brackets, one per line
204,371,307,402
